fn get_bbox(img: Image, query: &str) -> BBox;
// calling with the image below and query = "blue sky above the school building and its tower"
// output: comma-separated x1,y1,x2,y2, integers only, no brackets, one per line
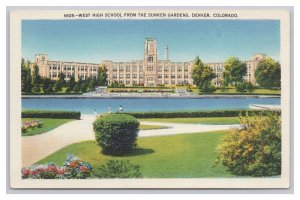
22,20,280,63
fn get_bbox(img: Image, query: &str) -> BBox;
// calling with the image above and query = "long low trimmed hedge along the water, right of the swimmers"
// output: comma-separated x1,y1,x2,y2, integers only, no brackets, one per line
127,110,280,118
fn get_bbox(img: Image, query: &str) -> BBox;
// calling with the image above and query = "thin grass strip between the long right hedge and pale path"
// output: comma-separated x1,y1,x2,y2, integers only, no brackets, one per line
139,117,239,124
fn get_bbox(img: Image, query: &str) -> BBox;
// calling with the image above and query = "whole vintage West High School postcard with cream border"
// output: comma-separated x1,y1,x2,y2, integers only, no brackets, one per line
9,7,292,189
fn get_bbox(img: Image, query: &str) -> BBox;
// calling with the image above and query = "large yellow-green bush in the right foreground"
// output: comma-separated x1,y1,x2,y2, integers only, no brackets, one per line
216,112,281,176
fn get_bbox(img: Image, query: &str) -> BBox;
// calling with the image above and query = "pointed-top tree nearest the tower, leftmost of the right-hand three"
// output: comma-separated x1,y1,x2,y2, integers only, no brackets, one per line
192,57,216,93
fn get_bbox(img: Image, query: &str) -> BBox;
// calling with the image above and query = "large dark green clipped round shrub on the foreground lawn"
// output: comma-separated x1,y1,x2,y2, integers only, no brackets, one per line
93,114,139,155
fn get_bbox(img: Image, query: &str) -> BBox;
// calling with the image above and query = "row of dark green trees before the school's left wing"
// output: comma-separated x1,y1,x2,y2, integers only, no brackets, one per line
21,58,107,94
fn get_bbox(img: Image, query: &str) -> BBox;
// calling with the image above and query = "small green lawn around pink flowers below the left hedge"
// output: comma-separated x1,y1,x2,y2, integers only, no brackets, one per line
22,118,74,136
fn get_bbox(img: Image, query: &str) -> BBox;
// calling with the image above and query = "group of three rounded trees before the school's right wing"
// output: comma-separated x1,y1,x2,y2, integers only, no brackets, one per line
192,57,281,93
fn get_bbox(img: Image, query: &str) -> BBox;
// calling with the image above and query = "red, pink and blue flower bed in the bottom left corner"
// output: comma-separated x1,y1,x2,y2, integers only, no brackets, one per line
21,155,92,179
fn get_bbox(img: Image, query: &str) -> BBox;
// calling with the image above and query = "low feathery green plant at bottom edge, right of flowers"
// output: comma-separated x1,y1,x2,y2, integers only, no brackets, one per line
94,160,142,178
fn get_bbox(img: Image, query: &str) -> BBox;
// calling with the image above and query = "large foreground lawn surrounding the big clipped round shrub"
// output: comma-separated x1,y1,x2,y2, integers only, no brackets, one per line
38,131,234,178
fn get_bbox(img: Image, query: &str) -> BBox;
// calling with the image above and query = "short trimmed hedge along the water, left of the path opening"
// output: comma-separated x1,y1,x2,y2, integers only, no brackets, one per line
22,110,81,119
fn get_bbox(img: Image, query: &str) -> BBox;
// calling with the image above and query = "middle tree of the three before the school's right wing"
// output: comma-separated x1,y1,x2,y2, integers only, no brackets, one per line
223,57,247,86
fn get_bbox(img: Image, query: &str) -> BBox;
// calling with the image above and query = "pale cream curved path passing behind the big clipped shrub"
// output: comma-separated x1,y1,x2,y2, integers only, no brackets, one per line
22,115,239,166
